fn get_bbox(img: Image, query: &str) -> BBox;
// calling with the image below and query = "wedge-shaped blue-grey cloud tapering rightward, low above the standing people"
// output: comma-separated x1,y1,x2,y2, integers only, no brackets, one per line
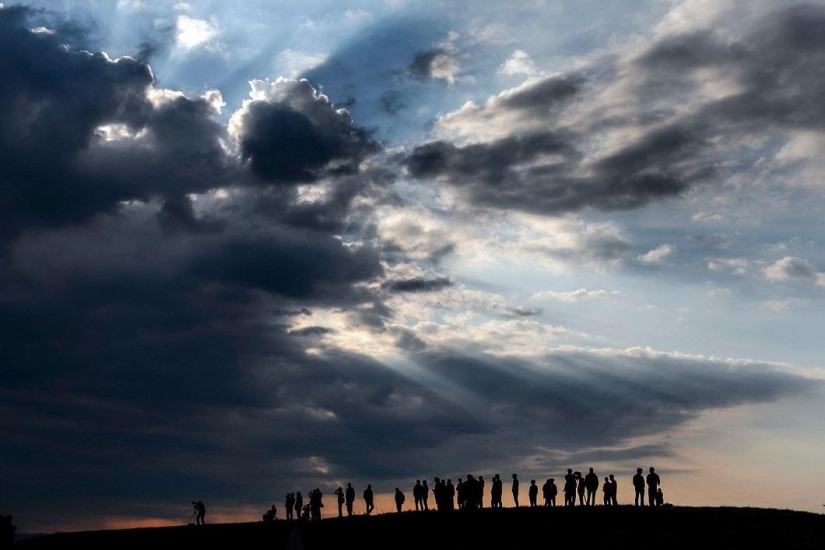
417,350,818,466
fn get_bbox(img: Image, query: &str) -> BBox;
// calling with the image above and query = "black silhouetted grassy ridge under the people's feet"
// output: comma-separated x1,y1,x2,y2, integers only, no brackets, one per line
14,506,825,550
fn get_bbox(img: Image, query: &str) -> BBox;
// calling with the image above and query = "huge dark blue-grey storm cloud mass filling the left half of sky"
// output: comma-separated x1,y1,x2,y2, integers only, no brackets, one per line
0,8,400,524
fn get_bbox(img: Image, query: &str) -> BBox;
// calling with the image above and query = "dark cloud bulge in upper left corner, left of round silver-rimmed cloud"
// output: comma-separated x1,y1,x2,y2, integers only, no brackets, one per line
0,8,237,247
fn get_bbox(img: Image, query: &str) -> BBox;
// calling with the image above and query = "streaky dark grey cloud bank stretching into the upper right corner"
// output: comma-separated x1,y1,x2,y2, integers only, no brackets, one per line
404,5,825,218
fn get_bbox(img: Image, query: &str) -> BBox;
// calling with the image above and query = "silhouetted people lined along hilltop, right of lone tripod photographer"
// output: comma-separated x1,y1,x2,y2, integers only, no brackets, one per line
260,466,665,523
